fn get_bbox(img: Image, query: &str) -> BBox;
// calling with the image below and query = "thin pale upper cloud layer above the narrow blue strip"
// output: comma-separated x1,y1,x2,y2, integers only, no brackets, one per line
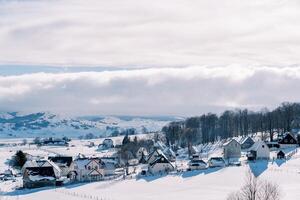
0,0,300,67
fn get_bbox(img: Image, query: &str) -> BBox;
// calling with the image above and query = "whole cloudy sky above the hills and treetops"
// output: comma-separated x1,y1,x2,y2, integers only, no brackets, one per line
0,0,300,115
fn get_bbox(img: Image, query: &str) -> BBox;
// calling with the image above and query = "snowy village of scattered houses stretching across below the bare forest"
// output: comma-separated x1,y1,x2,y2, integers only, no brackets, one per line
0,115,300,199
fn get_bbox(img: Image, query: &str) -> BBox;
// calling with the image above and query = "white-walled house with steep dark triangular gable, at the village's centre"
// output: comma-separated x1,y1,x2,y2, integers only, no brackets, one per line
148,153,175,174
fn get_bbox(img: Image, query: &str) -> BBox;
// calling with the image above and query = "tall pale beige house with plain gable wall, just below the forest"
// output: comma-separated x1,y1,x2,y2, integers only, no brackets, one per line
223,139,241,159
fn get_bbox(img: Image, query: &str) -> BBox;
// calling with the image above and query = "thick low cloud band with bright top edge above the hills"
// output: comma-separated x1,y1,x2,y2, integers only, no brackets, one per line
0,65,300,115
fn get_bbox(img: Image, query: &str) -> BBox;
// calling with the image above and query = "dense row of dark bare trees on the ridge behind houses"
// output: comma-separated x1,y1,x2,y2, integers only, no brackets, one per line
162,102,300,147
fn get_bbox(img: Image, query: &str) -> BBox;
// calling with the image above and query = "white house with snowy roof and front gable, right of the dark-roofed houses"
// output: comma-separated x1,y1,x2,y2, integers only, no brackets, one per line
74,158,104,181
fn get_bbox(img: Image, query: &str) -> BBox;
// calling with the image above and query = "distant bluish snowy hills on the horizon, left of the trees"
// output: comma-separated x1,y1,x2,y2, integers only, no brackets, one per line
0,112,175,138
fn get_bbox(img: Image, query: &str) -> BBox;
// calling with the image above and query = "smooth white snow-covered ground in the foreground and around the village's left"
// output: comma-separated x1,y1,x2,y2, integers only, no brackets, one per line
0,138,300,200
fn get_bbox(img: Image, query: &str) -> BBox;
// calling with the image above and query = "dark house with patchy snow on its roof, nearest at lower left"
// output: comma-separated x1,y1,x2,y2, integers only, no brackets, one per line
23,167,56,188
